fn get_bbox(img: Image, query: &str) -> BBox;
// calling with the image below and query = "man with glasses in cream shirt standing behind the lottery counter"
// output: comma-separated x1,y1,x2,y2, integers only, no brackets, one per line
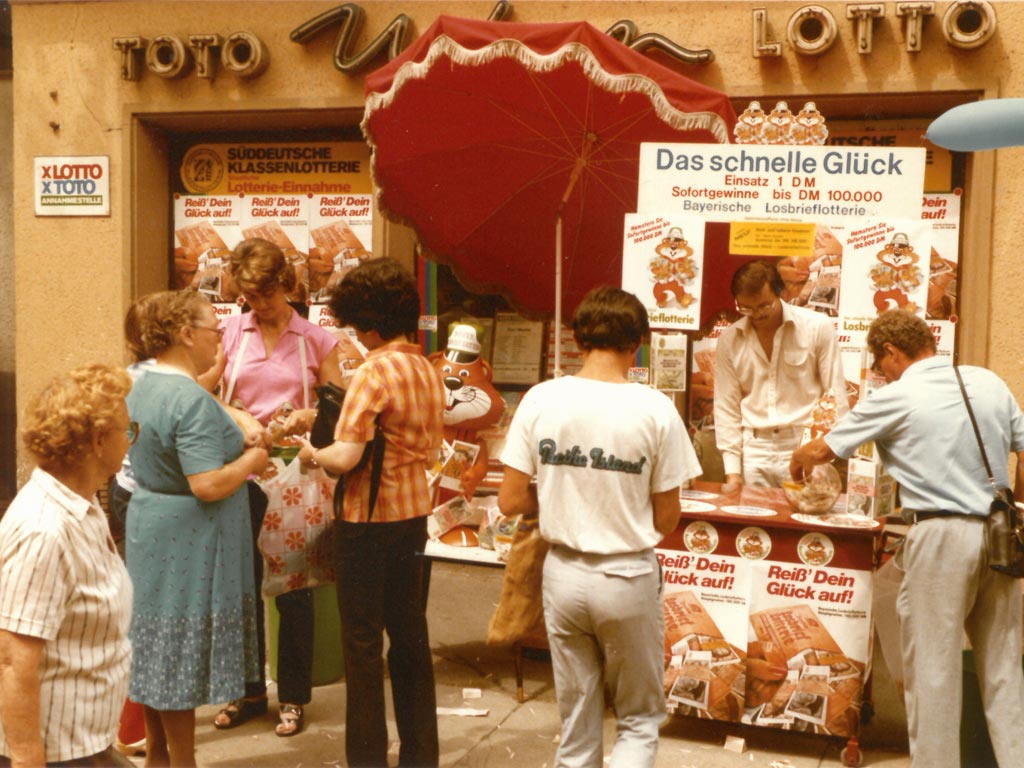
715,261,849,489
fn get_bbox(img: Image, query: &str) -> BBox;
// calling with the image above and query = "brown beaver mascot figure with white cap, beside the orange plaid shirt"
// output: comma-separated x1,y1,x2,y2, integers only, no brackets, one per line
429,325,505,501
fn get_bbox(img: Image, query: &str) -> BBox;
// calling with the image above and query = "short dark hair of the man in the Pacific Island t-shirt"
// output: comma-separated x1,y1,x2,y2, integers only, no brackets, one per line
572,286,650,352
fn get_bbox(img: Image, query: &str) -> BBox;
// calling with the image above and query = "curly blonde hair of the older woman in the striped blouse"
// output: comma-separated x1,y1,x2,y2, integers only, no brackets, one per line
22,362,131,469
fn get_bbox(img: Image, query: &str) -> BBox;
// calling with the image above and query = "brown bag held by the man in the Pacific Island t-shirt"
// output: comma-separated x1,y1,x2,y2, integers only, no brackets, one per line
487,522,548,648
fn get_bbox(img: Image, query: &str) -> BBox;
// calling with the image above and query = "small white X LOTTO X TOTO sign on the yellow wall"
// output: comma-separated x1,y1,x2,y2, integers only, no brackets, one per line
33,155,111,216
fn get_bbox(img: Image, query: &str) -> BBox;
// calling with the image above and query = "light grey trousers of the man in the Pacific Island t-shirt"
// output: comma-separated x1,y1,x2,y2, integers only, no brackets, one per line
544,546,666,768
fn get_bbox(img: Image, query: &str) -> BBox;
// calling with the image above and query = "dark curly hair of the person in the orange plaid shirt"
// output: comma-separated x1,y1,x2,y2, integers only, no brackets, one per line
329,256,420,341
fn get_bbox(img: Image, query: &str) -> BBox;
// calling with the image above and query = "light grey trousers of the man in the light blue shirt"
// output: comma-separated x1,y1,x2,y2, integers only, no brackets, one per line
896,517,1024,768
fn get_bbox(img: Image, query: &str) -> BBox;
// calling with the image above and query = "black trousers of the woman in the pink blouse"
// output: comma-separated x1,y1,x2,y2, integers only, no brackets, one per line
246,480,313,705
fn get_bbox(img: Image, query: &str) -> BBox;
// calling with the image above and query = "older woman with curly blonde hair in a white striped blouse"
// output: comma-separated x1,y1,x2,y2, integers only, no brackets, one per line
0,365,138,766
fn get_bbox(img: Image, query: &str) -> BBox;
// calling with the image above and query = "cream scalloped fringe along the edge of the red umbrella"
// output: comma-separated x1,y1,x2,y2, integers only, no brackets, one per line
360,35,729,148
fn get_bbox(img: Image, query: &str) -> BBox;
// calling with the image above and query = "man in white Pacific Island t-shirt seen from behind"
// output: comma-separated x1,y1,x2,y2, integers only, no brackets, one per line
499,287,700,768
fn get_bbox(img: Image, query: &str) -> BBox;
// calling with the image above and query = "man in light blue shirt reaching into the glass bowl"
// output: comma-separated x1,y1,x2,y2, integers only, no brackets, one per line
790,309,1024,768
